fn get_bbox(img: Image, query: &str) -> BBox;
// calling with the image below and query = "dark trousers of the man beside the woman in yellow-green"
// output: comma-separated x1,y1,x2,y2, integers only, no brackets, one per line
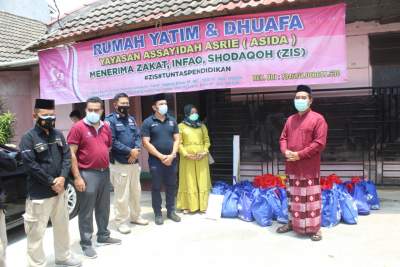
149,158,177,216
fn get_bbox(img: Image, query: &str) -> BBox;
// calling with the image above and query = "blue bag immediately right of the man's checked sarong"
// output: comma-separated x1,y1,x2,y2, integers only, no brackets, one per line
321,187,342,227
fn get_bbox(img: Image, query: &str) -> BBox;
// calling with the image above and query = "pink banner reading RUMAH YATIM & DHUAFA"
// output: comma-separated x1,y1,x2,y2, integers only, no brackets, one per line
39,4,347,104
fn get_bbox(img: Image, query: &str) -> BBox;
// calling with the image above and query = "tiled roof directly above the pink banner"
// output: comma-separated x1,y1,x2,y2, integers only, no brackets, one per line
30,0,296,49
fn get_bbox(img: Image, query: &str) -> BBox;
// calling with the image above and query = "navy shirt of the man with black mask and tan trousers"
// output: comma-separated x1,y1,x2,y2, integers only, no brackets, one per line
106,112,141,164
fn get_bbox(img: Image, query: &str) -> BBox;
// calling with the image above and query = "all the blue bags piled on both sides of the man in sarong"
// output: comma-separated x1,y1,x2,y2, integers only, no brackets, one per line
212,180,380,227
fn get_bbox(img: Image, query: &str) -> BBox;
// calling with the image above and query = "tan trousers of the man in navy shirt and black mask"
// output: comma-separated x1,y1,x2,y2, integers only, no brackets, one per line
111,162,142,226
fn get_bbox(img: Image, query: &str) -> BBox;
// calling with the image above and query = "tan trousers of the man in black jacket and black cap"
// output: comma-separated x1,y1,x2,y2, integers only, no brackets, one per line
23,192,71,267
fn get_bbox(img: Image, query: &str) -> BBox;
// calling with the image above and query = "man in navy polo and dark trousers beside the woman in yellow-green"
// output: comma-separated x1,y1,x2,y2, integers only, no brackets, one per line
142,94,181,225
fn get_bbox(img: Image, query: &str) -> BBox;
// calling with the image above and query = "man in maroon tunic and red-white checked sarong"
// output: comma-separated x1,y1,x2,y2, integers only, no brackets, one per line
277,85,328,241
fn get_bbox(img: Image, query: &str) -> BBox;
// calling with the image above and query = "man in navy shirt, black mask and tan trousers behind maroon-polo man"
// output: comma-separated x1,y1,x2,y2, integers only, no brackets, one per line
106,93,149,234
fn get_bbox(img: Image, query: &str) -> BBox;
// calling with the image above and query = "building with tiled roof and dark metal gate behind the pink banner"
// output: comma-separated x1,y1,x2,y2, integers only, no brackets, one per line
27,0,400,184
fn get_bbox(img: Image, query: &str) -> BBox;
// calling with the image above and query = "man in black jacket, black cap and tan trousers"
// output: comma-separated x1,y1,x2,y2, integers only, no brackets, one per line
20,99,81,267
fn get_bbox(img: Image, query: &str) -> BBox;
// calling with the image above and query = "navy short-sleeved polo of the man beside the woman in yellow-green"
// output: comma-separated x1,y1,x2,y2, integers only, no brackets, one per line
141,115,179,158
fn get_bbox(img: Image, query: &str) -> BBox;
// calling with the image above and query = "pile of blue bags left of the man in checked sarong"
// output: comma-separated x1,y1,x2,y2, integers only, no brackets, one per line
212,181,288,227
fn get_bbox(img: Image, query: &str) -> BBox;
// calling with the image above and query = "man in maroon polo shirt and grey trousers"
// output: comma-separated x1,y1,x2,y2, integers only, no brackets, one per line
67,97,121,258
